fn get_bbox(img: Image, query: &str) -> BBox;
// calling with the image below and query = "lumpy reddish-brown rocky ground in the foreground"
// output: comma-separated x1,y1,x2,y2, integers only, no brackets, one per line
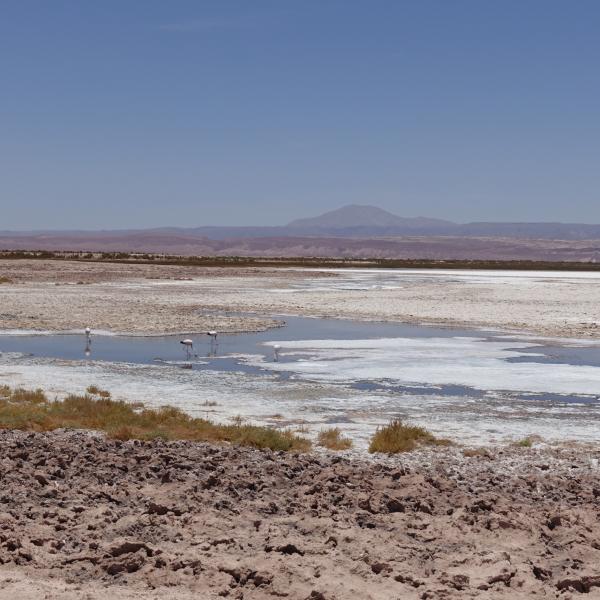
0,431,600,600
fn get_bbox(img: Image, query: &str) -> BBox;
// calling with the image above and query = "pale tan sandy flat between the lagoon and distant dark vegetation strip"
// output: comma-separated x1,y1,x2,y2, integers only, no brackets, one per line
0,261,600,338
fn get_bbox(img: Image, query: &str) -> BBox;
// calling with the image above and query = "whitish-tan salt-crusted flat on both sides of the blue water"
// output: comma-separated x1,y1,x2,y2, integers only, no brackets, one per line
0,261,600,451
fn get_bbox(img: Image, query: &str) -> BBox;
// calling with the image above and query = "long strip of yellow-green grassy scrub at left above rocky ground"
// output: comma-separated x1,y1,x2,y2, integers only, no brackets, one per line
0,386,311,452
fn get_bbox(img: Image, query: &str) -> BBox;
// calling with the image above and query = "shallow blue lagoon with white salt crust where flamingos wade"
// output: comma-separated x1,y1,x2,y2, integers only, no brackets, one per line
0,317,600,447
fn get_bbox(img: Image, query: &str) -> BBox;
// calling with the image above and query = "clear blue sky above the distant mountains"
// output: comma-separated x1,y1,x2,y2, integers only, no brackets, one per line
0,0,600,230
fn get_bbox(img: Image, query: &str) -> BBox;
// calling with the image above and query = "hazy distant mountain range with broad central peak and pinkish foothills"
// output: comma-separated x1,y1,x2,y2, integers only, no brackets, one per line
0,205,600,262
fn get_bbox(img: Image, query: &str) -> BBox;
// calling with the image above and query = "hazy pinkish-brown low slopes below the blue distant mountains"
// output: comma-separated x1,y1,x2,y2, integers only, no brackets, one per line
0,230,600,261
